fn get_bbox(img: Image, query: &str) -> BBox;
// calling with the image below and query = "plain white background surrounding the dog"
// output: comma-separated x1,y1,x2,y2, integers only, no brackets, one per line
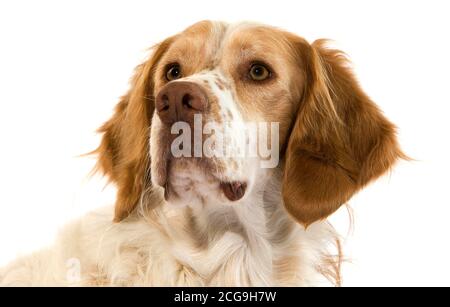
0,0,450,286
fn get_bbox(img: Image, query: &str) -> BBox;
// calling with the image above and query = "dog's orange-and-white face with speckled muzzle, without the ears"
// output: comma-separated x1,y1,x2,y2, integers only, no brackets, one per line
150,22,304,204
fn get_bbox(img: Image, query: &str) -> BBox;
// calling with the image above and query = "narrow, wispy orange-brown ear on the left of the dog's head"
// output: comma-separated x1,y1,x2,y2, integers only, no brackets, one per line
94,38,173,222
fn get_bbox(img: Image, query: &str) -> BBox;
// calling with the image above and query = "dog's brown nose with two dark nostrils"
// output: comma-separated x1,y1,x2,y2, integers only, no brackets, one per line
156,81,208,124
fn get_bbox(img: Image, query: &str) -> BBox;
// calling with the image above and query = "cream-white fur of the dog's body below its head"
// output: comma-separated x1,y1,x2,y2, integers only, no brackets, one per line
0,168,335,286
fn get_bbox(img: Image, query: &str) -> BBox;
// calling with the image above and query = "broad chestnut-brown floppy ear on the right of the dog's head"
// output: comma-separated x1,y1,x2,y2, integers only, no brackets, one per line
283,40,405,226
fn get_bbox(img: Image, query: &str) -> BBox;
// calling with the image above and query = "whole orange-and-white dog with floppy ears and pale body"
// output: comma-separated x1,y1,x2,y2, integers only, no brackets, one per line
0,21,405,286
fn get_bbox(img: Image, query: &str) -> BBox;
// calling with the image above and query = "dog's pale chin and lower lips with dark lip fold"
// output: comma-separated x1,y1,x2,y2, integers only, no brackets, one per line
156,159,248,206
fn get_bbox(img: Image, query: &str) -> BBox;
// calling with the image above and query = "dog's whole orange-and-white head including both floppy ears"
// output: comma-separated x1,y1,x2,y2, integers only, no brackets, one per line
97,21,403,225
